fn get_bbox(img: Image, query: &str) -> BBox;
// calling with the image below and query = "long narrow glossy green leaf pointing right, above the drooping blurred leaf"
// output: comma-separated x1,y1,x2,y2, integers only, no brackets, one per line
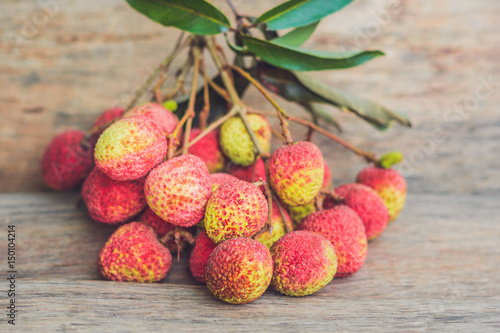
242,36,384,71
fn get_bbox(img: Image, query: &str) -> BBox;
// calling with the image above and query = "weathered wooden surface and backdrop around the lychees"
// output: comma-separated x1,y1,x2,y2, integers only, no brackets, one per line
0,0,500,332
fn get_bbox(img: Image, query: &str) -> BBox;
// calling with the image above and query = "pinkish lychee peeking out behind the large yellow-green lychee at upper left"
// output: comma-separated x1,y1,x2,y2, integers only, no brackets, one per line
123,103,179,134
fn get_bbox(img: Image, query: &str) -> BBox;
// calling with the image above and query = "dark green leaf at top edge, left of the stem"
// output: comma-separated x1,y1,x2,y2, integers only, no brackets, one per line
127,0,231,35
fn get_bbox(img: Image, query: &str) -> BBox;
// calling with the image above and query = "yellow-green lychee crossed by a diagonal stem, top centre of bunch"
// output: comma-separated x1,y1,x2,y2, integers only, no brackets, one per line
220,114,271,166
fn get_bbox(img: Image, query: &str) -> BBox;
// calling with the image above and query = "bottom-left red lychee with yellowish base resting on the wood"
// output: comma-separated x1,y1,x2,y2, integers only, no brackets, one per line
98,222,172,282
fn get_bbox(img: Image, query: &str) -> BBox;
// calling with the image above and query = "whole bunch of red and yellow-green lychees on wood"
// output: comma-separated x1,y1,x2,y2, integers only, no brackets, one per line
42,103,406,304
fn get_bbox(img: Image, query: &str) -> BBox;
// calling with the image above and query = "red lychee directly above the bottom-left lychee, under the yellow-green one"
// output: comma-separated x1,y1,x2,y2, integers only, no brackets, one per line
82,168,146,224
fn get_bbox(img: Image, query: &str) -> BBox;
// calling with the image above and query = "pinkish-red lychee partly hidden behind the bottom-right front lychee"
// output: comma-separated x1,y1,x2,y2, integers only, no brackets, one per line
297,205,368,277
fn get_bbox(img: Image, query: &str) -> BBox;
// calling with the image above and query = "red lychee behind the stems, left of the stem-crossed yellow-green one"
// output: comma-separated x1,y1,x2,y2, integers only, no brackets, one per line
188,128,226,173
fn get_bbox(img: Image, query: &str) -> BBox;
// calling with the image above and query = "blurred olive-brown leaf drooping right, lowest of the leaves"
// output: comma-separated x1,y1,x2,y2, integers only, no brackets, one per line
257,62,411,130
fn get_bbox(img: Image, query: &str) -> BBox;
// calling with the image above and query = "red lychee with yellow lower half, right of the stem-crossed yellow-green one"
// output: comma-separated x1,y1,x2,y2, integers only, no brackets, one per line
269,141,325,207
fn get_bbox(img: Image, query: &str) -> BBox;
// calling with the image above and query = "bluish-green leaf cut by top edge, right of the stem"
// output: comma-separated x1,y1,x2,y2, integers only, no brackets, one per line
255,0,353,30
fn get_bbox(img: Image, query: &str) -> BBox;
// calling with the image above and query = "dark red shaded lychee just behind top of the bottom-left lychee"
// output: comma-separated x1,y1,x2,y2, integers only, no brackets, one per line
135,207,193,253
